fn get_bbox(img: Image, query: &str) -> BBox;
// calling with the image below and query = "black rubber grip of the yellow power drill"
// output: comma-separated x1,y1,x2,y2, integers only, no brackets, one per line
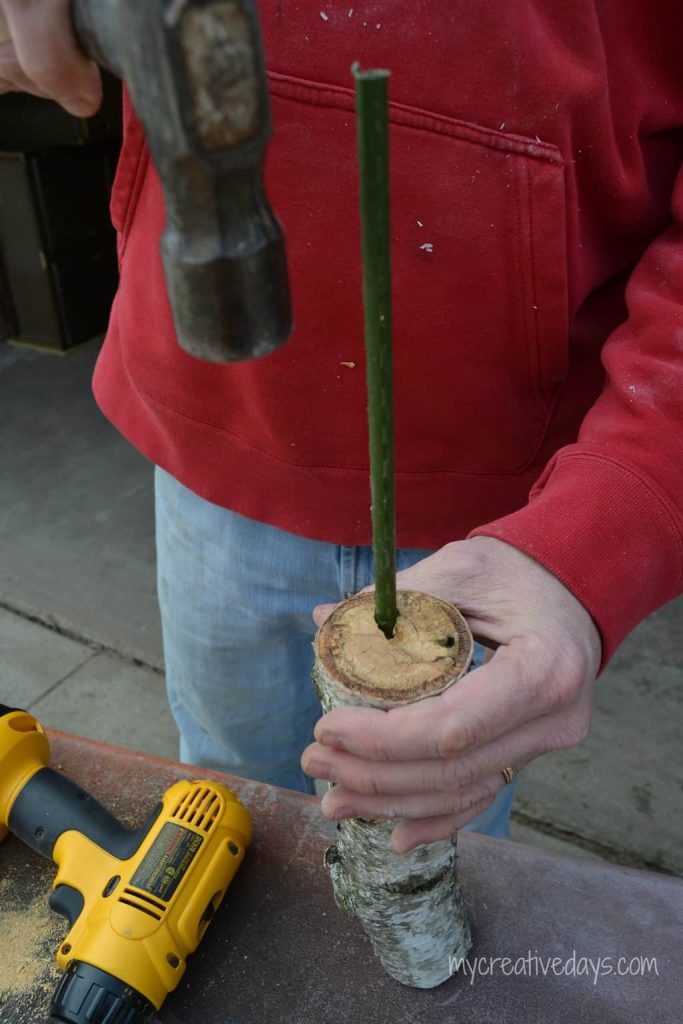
8,768,150,860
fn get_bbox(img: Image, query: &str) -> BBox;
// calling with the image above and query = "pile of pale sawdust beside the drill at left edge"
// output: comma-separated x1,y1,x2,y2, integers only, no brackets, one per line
0,878,66,1002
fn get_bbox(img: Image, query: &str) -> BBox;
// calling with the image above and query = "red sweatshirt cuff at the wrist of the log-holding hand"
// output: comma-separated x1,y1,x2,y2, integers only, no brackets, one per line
469,447,683,671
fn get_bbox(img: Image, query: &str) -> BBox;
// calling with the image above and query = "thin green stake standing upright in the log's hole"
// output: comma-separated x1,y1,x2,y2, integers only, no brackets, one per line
351,63,397,638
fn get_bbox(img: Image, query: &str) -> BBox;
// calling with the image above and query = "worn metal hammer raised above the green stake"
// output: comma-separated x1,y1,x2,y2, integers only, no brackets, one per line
72,0,292,362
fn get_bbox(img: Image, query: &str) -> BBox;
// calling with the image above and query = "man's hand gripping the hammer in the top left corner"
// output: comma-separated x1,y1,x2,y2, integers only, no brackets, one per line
0,0,102,118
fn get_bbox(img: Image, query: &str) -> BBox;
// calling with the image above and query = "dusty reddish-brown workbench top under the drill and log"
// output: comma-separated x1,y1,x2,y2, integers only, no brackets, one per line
0,733,683,1024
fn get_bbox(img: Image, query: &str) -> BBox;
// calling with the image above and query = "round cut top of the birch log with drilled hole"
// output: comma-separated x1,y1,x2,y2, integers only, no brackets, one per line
315,591,472,708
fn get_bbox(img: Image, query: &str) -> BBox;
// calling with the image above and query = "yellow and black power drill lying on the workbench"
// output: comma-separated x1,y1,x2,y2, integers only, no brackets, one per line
0,705,252,1024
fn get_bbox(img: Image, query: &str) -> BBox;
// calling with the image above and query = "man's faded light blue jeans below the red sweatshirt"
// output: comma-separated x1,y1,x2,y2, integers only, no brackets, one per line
155,469,514,838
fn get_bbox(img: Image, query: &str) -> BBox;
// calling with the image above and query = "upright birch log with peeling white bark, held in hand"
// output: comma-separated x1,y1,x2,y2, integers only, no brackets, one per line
313,591,472,988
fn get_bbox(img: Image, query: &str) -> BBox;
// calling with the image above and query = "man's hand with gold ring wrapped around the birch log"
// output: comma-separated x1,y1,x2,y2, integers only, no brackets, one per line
301,537,600,853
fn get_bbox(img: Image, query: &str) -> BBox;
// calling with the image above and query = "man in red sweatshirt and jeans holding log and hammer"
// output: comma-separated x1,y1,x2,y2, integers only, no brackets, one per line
0,0,683,850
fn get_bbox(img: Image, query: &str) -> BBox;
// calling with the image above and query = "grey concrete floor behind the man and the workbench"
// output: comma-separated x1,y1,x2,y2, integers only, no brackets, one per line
0,335,683,873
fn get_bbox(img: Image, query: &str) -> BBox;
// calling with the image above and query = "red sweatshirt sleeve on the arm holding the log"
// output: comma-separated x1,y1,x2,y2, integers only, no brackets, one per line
470,163,683,667
